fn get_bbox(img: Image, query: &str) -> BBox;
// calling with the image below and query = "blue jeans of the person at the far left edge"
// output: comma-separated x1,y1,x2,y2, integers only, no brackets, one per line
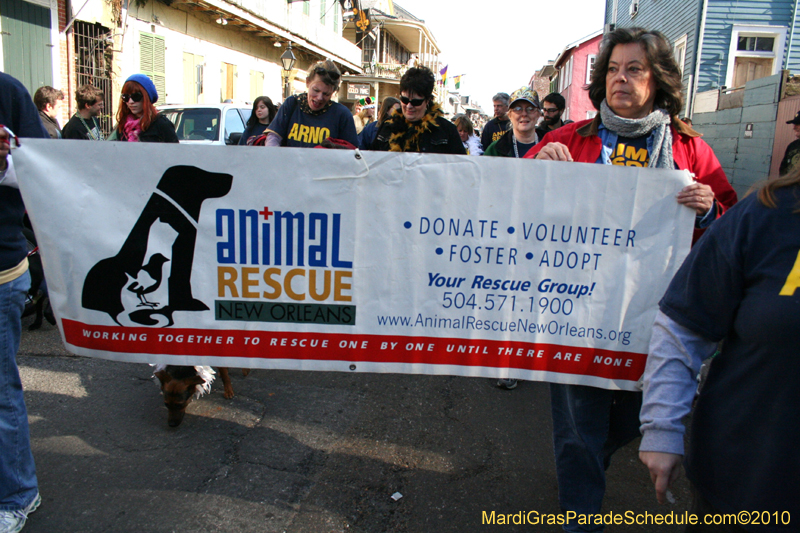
0,272,38,511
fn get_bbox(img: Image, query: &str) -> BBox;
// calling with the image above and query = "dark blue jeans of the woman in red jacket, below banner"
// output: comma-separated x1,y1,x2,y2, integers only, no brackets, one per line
550,383,642,532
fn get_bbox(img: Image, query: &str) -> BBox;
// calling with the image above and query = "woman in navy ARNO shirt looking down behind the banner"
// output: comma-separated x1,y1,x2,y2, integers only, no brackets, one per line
266,61,358,148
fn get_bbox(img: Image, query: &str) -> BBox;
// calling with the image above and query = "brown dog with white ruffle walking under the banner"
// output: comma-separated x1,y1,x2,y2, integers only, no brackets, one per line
153,365,245,427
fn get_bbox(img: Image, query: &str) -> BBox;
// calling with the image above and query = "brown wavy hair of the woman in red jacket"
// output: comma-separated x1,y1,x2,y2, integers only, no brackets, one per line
586,28,683,118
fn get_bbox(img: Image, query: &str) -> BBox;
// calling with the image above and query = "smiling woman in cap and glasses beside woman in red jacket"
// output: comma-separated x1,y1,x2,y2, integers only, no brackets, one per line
483,87,542,158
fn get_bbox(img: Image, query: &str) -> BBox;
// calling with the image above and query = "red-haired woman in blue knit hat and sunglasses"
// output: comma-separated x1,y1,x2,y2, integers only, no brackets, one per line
109,74,178,143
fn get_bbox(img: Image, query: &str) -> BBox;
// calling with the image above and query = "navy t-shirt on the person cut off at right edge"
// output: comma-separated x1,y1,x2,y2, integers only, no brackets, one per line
660,186,800,532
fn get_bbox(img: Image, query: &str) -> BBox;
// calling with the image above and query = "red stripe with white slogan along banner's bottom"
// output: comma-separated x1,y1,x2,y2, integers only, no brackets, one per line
62,319,646,381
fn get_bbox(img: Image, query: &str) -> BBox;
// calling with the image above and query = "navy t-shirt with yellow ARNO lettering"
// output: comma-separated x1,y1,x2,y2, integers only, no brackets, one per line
267,96,358,148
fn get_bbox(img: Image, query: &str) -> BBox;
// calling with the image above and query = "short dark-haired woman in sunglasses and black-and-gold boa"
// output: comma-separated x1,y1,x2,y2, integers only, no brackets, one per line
372,67,467,155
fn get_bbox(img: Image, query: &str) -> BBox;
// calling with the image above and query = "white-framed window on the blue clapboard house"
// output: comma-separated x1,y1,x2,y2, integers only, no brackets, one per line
724,26,787,87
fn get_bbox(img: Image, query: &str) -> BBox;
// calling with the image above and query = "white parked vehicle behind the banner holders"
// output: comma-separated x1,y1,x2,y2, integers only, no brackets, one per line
158,104,252,145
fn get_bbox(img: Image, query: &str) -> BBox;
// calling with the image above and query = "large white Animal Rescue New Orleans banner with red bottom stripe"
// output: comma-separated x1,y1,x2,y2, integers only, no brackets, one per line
13,140,694,390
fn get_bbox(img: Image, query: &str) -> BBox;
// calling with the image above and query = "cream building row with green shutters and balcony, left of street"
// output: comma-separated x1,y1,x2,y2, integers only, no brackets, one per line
0,0,362,133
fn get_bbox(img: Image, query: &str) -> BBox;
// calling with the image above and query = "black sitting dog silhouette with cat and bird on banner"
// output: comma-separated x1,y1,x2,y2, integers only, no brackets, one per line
82,166,233,326
